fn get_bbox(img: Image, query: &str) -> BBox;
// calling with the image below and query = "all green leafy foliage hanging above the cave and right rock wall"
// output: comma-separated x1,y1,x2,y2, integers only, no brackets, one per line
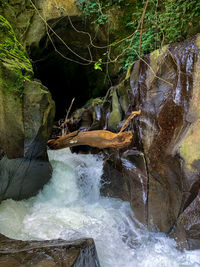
76,0,200,69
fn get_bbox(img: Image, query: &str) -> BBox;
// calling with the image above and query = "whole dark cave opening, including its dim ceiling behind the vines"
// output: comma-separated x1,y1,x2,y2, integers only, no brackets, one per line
30,17,121,120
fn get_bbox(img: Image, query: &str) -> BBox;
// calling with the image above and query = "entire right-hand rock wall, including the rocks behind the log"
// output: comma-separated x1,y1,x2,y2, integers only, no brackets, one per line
69,35,200,248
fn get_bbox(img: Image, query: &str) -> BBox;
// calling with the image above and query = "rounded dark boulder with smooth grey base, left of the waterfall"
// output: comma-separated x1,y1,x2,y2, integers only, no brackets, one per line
0,81,54,201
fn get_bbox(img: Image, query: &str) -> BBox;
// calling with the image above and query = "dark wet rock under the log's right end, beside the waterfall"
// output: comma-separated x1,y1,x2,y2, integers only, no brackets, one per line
101,150,148,224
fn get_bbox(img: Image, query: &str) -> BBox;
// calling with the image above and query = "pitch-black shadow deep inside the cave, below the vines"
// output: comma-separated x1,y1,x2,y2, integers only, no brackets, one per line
34,47,108,120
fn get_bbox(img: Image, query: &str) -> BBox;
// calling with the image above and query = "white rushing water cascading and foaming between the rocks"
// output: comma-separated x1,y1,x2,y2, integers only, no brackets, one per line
0,149,200,267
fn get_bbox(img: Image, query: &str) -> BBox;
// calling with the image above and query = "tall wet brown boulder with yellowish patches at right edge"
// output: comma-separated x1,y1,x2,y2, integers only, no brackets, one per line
130,36,200,236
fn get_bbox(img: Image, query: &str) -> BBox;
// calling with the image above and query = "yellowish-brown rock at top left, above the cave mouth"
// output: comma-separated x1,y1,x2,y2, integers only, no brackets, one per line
0,0,80,47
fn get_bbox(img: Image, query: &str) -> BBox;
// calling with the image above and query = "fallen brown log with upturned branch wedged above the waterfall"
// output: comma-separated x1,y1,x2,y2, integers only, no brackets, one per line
47,111,141,149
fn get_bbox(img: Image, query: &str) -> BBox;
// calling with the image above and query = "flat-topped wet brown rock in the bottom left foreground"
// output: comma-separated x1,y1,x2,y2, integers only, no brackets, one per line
0,235,100,267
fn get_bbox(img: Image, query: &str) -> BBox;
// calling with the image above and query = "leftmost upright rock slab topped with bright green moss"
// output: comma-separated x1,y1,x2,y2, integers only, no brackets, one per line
0,16,33,157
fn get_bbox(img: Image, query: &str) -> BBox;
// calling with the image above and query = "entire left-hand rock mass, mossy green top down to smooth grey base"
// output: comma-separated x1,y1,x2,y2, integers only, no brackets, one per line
0,16,55,201
